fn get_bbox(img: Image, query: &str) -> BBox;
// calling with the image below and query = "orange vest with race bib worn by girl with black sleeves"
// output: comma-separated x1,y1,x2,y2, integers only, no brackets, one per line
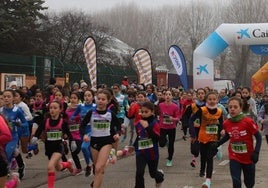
198,106,222,144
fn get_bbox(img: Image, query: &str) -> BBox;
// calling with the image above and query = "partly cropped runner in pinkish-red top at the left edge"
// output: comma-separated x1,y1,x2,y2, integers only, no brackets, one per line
0,115,19,188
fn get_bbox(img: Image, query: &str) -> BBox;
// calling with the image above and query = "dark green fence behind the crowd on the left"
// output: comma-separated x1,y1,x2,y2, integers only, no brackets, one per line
0,53,137,88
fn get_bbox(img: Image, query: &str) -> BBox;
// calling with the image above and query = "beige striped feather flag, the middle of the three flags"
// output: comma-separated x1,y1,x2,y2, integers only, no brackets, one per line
133,49,152,85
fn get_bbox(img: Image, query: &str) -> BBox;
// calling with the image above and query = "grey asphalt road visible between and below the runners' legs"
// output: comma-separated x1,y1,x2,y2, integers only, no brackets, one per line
16,130,268,188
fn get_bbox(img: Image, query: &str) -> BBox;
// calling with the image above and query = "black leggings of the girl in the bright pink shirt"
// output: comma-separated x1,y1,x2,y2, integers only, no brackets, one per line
159,128,176,161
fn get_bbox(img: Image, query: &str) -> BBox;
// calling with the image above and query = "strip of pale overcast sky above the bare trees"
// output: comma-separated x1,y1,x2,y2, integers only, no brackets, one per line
44,0,186,12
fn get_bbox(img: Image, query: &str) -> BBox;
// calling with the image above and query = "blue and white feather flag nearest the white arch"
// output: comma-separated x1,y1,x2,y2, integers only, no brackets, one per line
168,45,188,90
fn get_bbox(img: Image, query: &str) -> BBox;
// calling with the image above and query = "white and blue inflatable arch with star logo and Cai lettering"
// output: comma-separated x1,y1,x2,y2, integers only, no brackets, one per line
193,23,268,89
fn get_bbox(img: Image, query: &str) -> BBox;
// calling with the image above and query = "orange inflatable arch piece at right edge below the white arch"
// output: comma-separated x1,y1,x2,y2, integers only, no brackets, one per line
251,62,268,93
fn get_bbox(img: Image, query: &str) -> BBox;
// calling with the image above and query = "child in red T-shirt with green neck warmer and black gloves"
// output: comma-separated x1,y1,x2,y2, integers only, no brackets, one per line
215,97,262,188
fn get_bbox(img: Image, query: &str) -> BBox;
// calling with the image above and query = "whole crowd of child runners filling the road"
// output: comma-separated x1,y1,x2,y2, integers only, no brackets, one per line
0,77,268,188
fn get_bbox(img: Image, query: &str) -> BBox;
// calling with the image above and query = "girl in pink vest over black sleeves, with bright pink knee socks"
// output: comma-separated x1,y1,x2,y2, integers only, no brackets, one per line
31,101,74,188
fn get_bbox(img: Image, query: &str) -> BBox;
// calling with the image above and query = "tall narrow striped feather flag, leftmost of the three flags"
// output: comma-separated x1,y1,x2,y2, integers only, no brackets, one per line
83,37,97,88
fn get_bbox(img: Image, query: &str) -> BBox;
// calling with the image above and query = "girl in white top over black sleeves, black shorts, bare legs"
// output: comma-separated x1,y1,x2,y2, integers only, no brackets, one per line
81,90,121,188
